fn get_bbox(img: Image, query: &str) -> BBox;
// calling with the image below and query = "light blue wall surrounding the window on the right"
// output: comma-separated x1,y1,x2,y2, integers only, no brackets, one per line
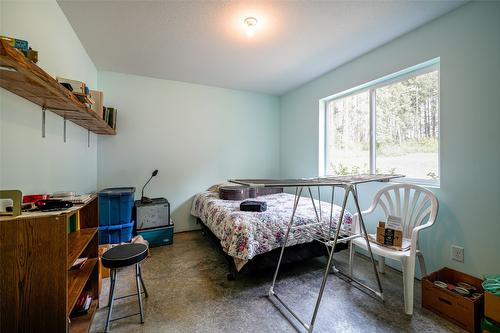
280,2,500,276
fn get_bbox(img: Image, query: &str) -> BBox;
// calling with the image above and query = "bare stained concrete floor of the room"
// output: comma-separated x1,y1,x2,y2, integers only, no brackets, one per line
91,231,463,333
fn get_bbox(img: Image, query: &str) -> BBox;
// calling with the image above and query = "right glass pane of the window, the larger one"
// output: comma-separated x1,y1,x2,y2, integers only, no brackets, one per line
375,70,439,180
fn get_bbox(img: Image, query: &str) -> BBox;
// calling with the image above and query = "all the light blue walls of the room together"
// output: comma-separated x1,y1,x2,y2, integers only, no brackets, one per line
0,1,500,276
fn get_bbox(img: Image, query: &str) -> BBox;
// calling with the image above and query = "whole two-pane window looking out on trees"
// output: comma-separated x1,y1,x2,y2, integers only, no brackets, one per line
322,59,439,184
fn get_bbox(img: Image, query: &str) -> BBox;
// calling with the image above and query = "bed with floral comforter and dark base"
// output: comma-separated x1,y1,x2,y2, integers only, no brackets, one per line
191,187,352,279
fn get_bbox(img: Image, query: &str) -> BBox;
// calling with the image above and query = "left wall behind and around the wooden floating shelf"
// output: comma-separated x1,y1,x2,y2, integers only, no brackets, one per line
0,0,97,193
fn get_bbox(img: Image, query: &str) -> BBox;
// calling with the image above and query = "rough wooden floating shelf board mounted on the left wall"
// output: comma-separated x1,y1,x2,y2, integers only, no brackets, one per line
0,40,116,135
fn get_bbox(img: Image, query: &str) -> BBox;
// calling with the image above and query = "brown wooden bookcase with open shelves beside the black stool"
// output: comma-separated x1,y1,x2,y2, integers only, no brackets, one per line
0,197,99,333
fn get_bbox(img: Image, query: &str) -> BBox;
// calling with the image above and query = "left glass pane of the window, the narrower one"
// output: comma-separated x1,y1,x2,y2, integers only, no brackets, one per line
326,91,370,175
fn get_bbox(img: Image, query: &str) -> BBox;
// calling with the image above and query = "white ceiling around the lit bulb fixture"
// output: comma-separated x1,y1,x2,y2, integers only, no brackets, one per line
58,0,464,95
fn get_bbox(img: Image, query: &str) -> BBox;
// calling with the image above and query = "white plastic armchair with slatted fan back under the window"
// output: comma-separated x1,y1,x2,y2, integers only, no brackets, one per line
349,184,439,315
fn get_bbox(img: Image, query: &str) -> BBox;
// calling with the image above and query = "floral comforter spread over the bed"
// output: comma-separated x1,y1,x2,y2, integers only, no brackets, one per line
191,191,352,269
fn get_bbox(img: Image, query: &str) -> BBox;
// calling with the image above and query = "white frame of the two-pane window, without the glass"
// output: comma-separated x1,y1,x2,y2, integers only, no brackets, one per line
319,58,441,187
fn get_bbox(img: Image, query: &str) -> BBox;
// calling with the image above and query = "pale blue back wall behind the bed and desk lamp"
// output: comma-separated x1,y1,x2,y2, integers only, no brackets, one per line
98,72,280,231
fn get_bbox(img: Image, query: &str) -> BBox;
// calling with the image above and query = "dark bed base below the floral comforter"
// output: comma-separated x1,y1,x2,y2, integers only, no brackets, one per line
197,218,348,281
